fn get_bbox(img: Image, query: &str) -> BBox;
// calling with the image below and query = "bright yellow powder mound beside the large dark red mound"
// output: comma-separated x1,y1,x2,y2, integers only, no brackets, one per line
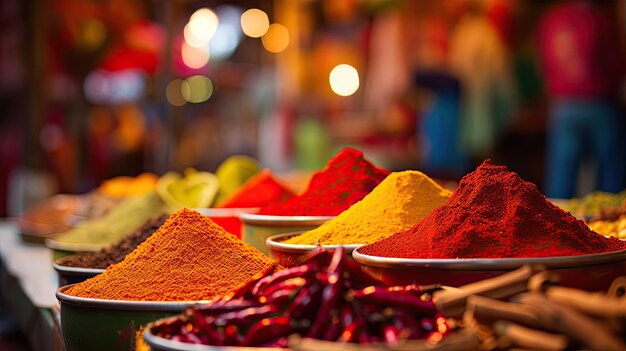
285,171,451,245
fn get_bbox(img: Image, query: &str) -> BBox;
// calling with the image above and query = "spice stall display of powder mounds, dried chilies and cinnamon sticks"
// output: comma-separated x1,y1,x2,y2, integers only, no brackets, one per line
0,148,626,351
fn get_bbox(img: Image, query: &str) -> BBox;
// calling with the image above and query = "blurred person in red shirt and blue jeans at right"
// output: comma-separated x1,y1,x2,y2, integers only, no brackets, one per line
538,1,625,198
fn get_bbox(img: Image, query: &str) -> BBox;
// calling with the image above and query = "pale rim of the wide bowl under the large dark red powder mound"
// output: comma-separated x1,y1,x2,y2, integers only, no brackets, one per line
352,248,626,270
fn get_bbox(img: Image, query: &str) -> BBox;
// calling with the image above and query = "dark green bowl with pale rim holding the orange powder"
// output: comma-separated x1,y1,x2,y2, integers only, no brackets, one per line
56,285,207,351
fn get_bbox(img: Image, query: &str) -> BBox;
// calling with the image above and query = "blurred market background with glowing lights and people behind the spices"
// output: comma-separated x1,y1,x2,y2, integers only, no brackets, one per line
0,0,626,216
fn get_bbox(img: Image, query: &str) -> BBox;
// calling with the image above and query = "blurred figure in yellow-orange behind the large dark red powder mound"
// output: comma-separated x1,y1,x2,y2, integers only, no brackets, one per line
448,3,517,163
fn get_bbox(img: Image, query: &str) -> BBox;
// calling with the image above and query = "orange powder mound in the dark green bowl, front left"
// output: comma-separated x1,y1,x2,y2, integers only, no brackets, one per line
66,209,276,301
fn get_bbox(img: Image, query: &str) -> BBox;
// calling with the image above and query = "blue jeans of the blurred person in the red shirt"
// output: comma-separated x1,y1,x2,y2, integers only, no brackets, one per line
546,100,626,199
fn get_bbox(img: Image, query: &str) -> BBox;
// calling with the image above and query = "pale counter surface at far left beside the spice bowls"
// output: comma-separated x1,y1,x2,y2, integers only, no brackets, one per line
0,221,65,351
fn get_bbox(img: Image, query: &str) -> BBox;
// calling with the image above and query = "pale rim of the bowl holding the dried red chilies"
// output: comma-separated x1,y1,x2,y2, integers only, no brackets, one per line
143,324,290,351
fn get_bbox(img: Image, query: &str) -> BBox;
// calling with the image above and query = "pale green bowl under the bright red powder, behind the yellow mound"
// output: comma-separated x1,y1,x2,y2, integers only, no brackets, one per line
239,213,335,256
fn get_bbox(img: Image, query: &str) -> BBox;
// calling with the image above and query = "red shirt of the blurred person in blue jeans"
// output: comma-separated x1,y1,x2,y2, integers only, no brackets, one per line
538,1,621,98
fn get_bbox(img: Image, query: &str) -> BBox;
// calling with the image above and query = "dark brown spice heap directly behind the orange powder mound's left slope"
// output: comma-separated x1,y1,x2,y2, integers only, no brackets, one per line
57,214,168,269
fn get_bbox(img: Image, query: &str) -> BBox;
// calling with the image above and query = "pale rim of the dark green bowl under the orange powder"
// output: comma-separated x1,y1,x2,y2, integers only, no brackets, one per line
55,283,210,312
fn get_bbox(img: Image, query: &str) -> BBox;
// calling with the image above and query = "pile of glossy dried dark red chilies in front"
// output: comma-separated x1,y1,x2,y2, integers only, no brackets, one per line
151,248,450,347
